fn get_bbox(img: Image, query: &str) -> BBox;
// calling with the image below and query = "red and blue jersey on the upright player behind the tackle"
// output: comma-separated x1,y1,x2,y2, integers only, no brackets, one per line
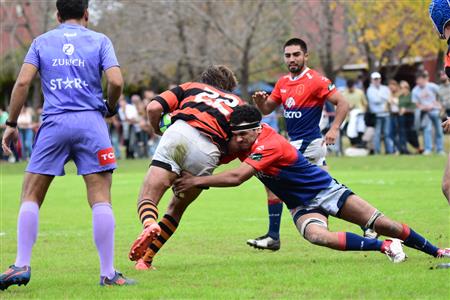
271,68,336,142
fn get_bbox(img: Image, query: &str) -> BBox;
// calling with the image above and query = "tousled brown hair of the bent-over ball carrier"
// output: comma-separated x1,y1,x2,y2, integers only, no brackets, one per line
200,65,237,92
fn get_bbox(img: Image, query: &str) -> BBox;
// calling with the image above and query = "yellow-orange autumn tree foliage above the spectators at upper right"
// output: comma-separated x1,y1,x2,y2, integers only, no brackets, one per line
348,0,439,78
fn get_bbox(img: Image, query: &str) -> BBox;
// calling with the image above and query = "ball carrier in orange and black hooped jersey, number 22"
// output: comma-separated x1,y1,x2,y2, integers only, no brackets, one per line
129,66,244,270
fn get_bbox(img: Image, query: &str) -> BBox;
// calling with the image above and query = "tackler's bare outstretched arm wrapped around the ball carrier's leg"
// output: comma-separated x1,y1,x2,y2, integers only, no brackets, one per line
174,162,256,194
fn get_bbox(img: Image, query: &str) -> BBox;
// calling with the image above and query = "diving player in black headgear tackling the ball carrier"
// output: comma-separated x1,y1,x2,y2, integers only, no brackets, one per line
175,106,450,263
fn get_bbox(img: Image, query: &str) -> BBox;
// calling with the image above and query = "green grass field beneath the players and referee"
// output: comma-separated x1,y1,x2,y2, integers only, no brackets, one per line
0,156,450,299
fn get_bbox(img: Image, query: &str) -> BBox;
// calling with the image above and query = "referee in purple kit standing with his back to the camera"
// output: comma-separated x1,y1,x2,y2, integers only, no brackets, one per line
0,0,134,290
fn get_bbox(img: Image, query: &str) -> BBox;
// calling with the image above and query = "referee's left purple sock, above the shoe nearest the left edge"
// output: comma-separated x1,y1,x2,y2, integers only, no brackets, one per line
14,201,39,267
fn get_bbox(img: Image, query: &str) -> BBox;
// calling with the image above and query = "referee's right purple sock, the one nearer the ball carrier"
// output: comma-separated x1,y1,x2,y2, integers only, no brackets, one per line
92,203,115,279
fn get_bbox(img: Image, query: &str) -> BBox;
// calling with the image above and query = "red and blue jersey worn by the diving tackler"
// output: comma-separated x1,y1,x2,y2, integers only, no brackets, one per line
240,124,332,208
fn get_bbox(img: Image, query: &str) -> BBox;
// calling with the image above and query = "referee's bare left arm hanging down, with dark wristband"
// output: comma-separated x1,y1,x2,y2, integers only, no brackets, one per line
2,63,37,155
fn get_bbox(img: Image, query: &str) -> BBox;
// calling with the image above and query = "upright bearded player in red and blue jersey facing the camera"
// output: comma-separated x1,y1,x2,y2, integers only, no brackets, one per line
247,38,349,251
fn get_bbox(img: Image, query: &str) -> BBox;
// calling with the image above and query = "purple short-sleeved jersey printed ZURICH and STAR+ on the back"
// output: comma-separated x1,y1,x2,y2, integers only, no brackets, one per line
24,24,119,117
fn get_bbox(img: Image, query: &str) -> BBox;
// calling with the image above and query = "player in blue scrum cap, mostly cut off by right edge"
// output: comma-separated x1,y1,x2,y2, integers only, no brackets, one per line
429,0,450,204
